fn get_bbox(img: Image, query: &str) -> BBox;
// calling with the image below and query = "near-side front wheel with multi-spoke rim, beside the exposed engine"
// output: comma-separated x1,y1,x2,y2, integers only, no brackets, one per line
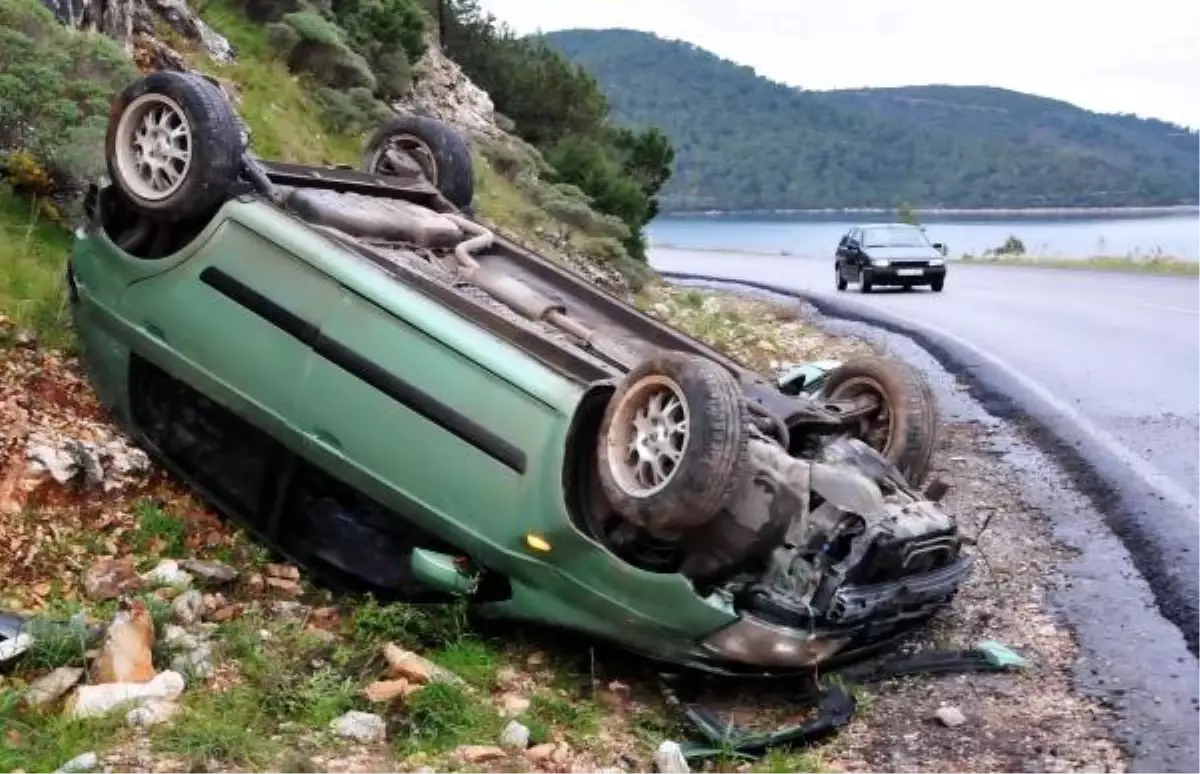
596,352,749,538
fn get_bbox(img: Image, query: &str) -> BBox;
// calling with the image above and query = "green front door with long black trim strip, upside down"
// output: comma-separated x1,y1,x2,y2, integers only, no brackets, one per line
288,276,553,548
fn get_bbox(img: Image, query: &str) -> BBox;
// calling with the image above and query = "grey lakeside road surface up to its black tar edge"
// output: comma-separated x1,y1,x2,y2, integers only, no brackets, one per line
650,250,1200,638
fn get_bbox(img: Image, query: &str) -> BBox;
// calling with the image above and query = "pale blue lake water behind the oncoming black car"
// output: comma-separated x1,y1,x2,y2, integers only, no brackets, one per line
647,212,1200,260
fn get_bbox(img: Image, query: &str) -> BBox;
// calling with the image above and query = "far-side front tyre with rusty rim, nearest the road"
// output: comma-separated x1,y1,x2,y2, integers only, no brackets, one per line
821,358,937,485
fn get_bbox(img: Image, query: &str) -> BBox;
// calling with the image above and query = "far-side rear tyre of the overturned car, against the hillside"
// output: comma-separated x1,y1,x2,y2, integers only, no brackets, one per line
362,115,475,209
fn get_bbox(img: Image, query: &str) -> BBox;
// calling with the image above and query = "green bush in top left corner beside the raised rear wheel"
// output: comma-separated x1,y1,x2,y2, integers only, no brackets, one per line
0,0,137,194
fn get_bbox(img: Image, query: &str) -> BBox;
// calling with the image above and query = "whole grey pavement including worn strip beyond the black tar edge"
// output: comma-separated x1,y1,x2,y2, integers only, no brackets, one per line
650,250,1200,772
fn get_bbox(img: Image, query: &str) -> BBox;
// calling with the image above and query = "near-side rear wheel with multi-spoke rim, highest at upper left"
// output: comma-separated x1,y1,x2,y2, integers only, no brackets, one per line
104,71,245,222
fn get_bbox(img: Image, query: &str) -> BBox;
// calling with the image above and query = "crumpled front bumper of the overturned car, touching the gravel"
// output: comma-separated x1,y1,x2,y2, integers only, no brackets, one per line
703,554,972,668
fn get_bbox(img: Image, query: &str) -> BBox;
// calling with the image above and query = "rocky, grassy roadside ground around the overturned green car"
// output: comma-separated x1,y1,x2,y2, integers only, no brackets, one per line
0,284,1123,774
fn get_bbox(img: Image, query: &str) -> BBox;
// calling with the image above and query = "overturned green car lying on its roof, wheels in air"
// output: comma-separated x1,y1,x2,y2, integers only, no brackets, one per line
67,72,971,673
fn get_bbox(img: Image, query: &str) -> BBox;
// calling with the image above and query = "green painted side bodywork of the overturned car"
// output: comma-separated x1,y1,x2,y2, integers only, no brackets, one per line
71,192,737,661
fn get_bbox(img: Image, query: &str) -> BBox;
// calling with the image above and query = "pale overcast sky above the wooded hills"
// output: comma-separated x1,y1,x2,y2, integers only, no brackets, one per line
472,0,1200,128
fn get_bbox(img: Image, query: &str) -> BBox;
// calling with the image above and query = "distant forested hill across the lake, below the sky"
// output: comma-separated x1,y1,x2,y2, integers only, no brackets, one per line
544,30,1200,210
